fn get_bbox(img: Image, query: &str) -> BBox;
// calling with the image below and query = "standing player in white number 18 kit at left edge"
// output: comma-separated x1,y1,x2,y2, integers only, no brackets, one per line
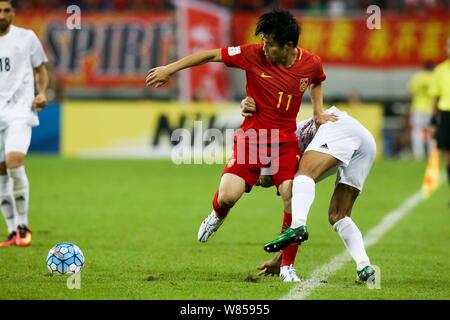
0,0,48,247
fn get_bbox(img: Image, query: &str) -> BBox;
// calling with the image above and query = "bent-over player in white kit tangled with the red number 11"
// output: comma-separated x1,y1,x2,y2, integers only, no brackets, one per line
243,98,376,282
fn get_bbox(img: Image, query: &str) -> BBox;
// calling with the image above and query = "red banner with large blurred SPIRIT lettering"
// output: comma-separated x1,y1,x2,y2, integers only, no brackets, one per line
15,13,174,88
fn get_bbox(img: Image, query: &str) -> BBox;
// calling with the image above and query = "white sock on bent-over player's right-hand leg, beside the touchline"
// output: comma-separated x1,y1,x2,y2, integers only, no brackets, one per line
333,217,370,270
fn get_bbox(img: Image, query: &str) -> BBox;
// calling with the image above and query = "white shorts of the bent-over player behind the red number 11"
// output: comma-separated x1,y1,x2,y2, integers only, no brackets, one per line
305,115,376,192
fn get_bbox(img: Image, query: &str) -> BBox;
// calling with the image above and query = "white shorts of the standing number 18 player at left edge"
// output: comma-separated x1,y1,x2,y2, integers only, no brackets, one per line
0,123,31,162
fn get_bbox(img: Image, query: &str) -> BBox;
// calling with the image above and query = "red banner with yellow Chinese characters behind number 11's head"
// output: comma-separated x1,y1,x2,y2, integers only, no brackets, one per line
232,13,450,68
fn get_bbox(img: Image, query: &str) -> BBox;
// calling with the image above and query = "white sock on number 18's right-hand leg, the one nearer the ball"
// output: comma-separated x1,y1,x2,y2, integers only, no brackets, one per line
7,166,30,226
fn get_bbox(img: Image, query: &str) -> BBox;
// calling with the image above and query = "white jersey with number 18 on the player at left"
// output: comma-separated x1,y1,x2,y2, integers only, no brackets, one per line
0,25,48,130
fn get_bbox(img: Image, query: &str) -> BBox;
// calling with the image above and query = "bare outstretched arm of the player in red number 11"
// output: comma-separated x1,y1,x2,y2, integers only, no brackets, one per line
145,49,222,88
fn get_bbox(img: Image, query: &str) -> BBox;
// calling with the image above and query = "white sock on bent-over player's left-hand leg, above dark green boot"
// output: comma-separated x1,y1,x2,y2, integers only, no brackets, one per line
291,176,316,228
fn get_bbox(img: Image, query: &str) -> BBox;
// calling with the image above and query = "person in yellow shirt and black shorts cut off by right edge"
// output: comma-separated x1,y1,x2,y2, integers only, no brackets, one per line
430,37,450,205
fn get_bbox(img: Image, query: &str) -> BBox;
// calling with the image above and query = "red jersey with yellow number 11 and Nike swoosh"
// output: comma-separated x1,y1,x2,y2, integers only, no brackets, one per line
222,44,326,143
